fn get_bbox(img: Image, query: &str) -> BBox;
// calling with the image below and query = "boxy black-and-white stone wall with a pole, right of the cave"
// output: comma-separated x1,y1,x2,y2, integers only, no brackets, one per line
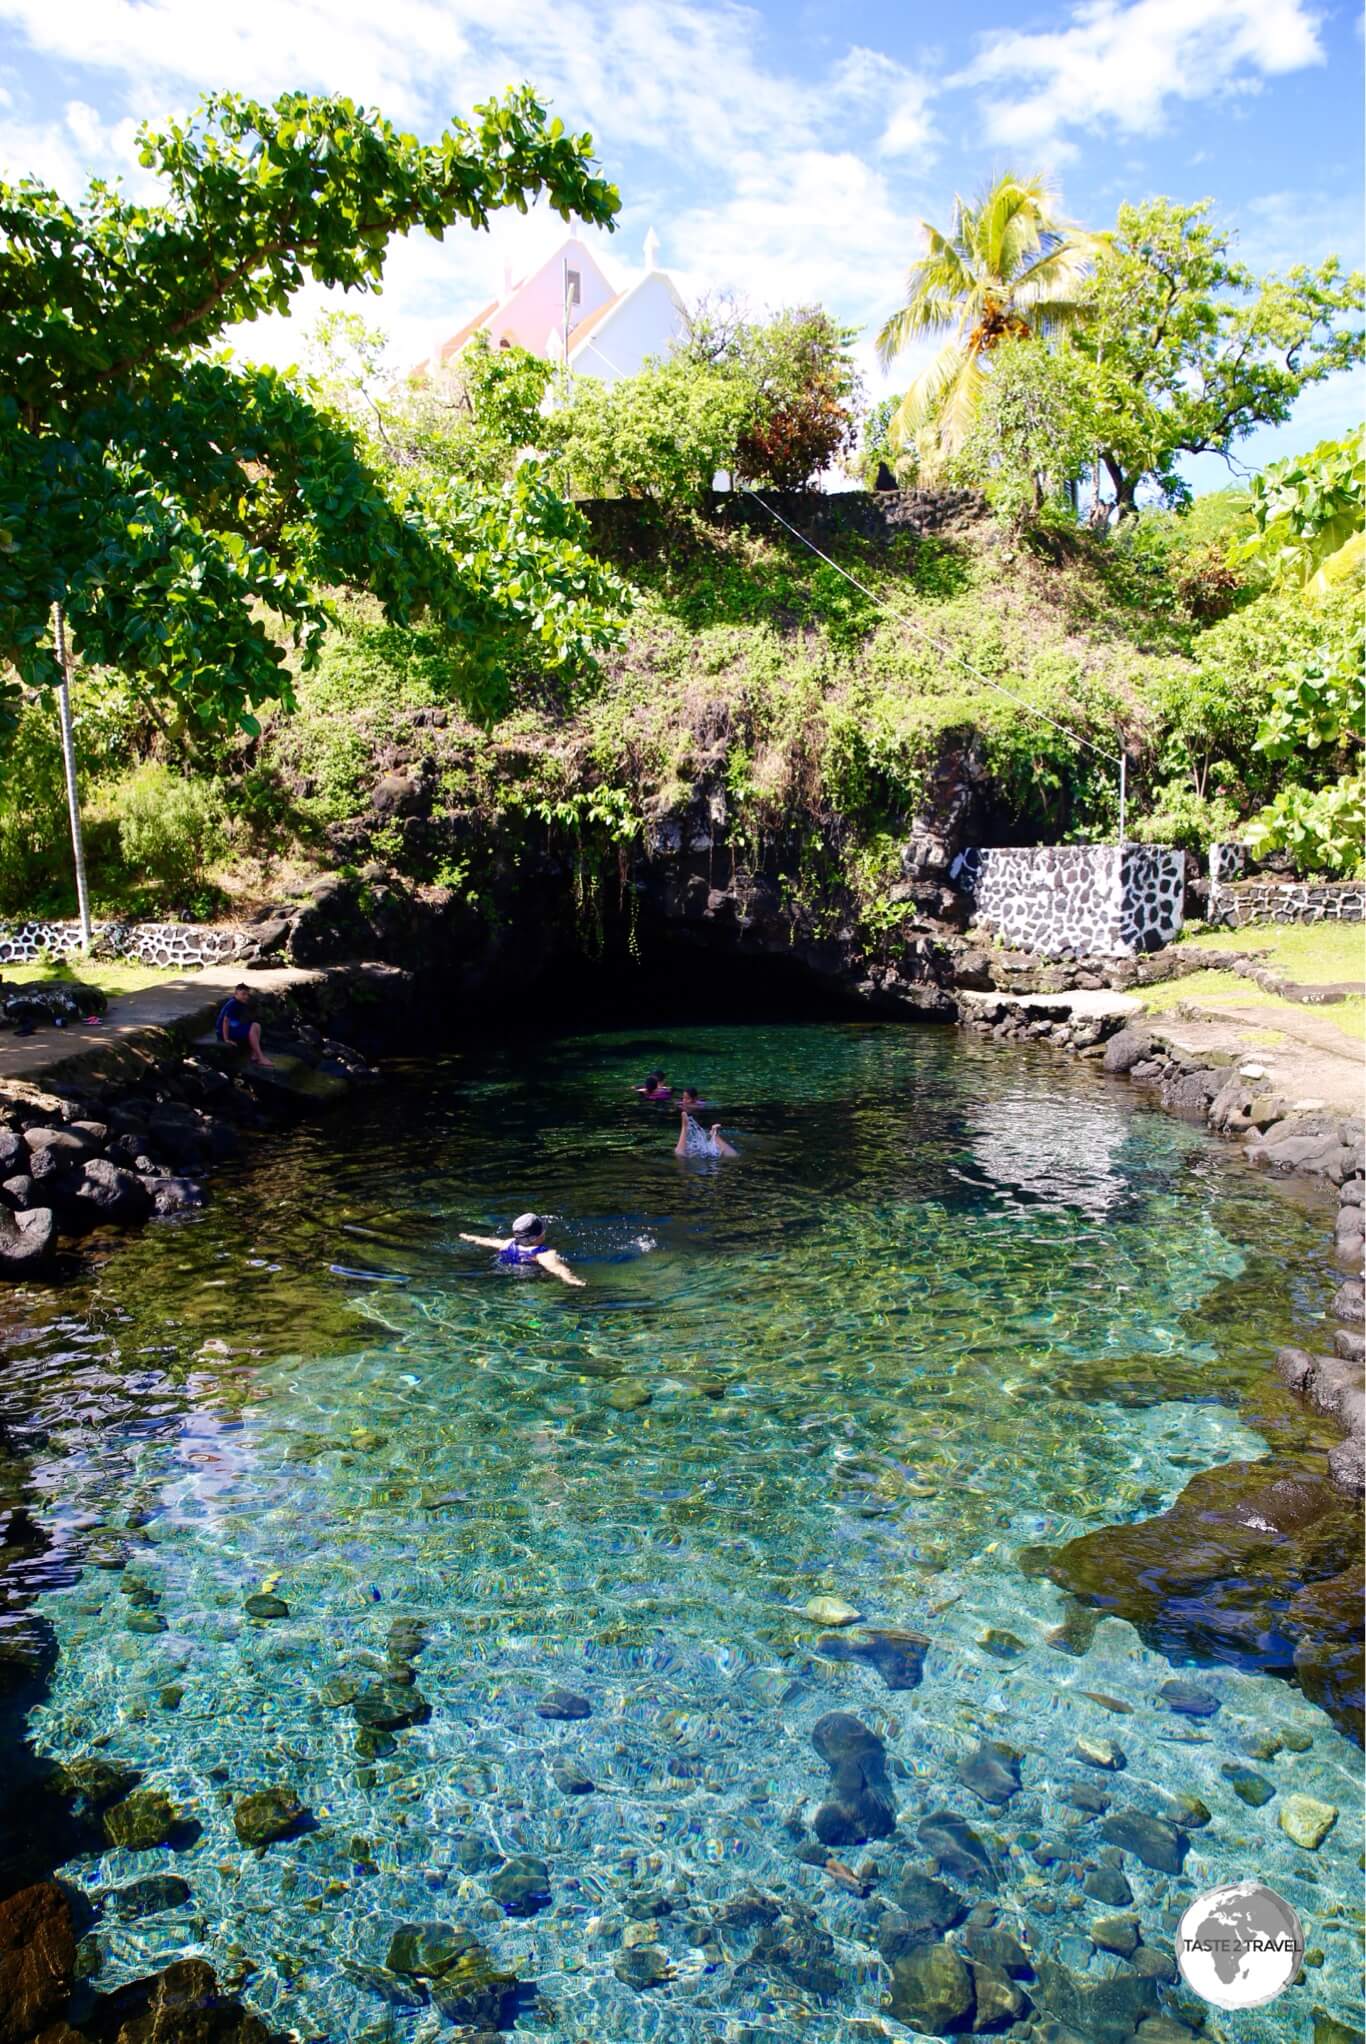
951,844,1186,959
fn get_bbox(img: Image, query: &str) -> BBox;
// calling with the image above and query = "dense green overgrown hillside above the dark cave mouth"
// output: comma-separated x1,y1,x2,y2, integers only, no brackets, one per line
0,497,1352,924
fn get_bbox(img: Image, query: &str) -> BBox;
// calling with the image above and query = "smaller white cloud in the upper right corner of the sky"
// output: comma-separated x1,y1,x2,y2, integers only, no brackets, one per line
955,0,1323,159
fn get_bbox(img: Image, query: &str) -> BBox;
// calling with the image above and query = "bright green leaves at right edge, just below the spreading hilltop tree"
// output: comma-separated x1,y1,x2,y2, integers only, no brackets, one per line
1233,427,1366,599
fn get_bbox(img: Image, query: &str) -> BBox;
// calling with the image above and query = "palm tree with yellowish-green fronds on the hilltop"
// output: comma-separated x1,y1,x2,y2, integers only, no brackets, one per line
877,172,1108,460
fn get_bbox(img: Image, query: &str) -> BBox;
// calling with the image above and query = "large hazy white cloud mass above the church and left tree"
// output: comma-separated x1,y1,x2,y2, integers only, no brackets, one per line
0,0,948,386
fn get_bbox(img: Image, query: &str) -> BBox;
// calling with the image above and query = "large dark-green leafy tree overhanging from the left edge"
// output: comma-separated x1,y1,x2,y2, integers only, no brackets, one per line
0,88,620,730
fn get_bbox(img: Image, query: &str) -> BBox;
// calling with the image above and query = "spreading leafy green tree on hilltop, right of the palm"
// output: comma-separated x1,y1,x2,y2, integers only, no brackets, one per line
1074,198,1362,517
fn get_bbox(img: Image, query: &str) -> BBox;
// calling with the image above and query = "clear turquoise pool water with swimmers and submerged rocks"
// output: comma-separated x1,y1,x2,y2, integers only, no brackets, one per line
10,1024,1360,2044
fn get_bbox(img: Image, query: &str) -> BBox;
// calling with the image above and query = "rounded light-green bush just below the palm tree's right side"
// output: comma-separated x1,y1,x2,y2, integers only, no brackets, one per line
953,339,1096,527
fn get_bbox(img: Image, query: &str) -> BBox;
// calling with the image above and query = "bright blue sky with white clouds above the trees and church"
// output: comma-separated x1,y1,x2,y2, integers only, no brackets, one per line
0,0,1366,489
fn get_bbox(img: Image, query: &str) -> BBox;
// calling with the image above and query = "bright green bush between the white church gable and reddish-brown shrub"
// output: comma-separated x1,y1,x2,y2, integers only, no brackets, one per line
550,356,753,509
